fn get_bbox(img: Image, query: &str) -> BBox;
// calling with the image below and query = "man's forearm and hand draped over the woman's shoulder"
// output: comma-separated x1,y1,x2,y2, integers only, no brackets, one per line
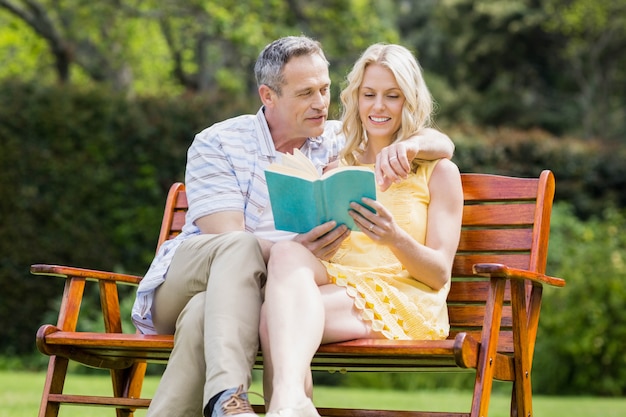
376,128,454,191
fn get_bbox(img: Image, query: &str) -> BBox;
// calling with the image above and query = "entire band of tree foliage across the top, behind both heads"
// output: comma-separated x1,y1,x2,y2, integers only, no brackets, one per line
0,0,626,142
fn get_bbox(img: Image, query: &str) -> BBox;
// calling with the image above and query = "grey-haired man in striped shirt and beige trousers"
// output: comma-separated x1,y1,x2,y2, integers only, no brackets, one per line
133,36,454,417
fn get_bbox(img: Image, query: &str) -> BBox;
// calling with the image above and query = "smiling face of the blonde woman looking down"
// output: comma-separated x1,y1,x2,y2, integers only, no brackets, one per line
359,64,405,144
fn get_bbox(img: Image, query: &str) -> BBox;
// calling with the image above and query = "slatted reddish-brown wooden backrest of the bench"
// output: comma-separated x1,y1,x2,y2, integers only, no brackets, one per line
158,171,554,353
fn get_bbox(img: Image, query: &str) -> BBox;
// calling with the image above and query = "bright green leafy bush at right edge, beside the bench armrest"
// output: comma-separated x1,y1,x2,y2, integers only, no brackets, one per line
534,204,626,396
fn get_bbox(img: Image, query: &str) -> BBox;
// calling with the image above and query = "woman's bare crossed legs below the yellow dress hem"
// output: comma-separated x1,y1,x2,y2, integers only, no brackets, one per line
260,242,381,412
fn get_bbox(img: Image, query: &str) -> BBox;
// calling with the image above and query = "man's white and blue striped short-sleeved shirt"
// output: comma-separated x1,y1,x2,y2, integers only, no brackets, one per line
132,108,344,334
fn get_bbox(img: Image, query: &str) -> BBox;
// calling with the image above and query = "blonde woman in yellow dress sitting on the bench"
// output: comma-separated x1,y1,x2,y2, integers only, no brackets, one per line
260,44,463,417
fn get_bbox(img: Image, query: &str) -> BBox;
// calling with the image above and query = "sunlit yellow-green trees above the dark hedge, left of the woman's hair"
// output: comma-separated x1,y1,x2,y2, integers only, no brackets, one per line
0,0,398,98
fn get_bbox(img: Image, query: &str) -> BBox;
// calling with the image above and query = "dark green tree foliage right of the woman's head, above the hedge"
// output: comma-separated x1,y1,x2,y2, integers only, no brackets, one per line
398,0,626,142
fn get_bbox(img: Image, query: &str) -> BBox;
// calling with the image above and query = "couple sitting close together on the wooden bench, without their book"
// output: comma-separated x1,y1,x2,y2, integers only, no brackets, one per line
133,36,463,417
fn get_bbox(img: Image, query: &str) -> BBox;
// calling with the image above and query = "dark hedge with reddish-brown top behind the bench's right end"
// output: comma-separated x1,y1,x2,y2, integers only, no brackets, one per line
443,126,626,219
